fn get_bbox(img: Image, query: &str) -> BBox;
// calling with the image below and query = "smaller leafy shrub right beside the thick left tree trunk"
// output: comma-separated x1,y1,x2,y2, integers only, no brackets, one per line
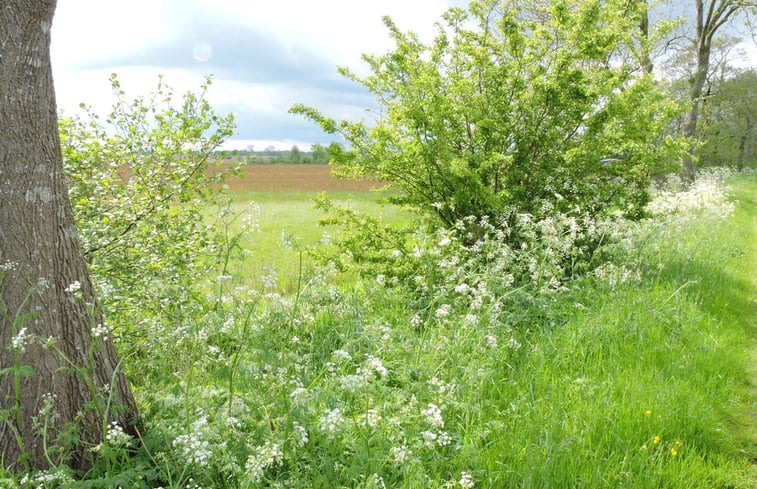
60,75,239,332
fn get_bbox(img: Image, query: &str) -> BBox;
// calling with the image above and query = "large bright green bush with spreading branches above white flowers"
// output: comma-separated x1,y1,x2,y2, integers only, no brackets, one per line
291,0,681,228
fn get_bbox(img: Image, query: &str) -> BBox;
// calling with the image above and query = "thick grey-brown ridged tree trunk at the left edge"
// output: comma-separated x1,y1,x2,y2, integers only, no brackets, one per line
0,0,138,470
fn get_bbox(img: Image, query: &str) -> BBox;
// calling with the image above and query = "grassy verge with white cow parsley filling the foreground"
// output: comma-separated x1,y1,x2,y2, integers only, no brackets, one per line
124,173,757,489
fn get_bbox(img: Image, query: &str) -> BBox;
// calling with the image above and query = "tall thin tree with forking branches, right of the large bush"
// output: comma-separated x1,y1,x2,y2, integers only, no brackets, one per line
681,0,757,180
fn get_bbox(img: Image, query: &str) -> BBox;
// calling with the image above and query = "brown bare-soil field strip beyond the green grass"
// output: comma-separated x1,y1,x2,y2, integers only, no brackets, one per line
226,164,386,192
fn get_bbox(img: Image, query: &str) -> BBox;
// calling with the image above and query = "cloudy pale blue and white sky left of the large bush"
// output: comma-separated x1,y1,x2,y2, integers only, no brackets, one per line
51,0,467,150
